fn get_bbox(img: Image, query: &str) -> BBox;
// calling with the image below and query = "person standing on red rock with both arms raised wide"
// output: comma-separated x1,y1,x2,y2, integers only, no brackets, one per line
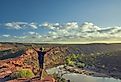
32,45,54,79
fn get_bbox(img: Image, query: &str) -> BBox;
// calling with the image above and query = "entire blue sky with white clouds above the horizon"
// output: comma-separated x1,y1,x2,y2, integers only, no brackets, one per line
0,0,121,43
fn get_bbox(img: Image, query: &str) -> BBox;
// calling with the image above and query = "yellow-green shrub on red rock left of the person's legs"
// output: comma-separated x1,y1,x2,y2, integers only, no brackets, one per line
10,69,35,79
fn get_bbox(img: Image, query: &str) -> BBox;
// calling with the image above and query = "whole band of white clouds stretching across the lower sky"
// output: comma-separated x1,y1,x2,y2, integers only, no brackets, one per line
3,22,121,42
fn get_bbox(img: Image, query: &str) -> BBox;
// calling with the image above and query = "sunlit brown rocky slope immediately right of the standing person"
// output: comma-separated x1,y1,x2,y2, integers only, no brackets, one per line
45,47,67,68
